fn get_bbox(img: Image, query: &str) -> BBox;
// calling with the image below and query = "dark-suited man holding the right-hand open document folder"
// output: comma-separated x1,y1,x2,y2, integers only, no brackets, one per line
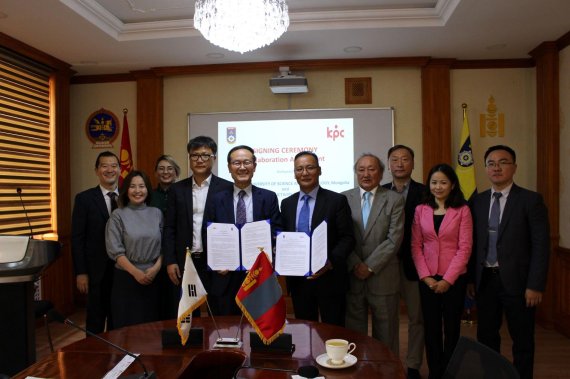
277,151,354,326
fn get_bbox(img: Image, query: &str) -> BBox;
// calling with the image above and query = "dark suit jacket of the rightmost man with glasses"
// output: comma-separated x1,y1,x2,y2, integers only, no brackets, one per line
471,184,550,295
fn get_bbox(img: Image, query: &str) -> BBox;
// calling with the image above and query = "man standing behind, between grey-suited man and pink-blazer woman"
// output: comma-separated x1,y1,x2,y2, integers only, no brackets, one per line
383,145,425,379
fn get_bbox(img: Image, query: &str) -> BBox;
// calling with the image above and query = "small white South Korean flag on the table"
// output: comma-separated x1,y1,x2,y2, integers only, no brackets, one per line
176,250,207,345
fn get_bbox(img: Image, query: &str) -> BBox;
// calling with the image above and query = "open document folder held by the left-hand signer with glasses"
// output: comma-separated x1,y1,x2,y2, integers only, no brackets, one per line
207,220,272,271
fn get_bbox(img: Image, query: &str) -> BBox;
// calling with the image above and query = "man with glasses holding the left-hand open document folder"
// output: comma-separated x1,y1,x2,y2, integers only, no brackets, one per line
204,145,280,316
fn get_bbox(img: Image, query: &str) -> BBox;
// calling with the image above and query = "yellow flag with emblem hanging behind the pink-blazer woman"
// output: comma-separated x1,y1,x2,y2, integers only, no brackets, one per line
455,103,477,200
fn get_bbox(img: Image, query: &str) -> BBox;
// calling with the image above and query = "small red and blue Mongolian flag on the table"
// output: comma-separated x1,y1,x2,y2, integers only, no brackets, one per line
236,251,285,345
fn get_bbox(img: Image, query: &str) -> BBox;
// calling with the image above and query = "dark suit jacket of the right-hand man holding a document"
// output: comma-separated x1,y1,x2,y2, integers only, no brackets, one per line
281,187,354,296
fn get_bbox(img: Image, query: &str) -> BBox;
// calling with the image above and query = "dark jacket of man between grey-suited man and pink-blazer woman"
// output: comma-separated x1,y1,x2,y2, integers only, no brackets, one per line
382,180,425,281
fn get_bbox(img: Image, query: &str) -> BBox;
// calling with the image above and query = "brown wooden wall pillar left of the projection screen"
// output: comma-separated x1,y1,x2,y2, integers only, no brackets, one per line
133,70,164,186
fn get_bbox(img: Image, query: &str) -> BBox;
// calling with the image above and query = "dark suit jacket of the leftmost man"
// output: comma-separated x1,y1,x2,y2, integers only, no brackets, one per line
71,186,114,285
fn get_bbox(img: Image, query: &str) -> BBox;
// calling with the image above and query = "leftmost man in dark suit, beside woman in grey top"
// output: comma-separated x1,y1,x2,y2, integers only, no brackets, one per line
71,151,121,333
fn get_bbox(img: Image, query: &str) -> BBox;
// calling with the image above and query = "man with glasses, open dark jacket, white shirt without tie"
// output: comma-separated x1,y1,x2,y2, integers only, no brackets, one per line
162,136,232,318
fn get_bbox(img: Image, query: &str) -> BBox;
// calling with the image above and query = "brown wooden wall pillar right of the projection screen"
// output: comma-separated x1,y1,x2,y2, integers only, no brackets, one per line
422,59,454,178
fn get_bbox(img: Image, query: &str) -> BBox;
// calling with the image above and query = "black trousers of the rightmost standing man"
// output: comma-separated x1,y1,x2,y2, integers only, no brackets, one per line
477,269,536,379
